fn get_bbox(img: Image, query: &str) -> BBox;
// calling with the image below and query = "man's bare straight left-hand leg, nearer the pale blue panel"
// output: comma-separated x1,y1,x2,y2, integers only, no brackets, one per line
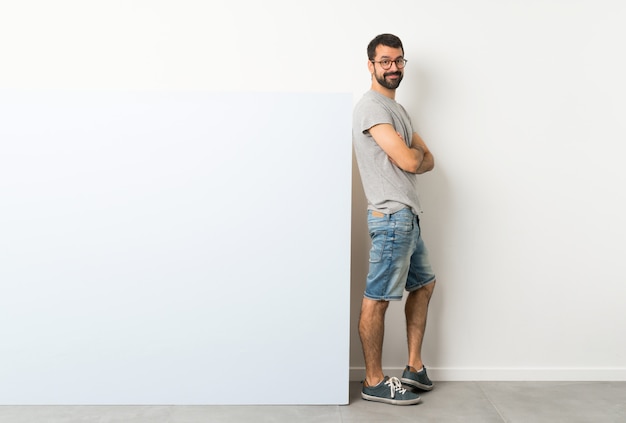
359,298,389,386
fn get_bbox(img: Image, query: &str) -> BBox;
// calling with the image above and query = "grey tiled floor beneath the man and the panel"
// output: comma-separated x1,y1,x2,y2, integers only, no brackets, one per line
0,382,626,423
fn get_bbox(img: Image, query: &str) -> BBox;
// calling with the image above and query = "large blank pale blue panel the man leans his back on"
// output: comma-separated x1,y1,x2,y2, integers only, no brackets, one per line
0,92,351,404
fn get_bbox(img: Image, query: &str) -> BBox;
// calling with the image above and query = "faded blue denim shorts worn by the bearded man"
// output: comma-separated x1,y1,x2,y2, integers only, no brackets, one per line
365,208,435,301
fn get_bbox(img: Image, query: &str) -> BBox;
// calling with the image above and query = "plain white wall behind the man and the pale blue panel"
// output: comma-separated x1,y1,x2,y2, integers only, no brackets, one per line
0,0,626,390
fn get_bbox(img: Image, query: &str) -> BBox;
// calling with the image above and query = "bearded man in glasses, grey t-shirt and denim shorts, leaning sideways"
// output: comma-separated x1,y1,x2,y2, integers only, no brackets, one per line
353,34,435,405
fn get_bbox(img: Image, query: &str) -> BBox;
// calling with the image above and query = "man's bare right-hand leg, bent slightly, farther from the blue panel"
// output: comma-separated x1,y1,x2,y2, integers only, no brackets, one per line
404,282,435,371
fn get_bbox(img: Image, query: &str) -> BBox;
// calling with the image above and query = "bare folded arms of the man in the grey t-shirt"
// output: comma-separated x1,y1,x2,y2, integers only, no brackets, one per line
369,123,435,174
